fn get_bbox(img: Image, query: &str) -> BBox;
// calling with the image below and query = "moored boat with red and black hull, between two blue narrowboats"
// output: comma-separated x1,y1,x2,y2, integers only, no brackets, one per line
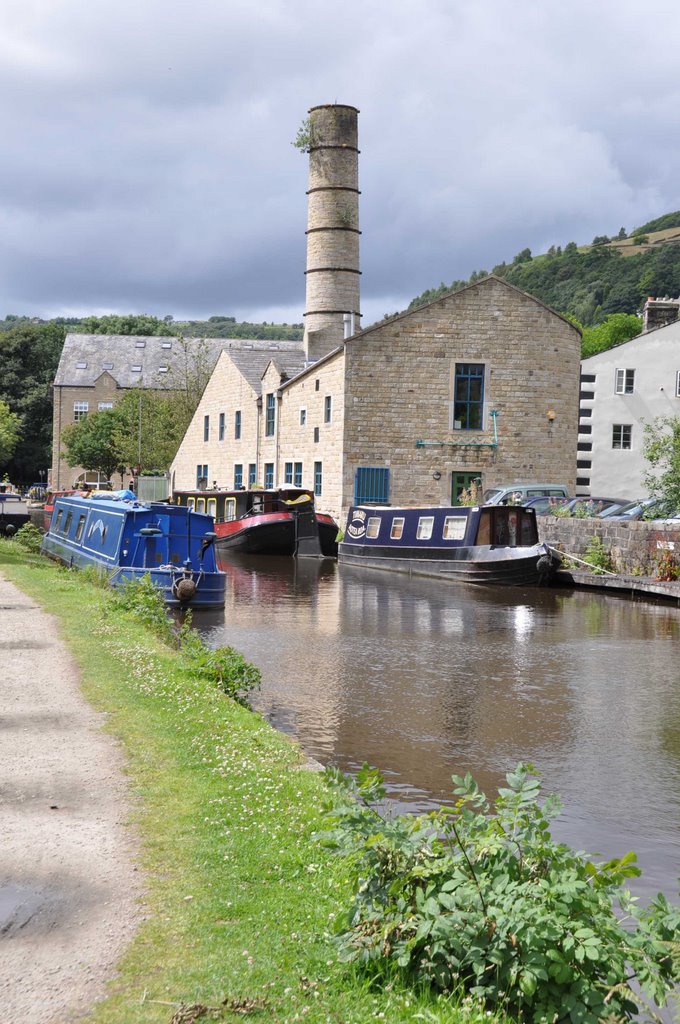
174,487,338,566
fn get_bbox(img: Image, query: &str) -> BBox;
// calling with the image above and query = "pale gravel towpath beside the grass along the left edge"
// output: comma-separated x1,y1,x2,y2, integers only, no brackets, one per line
0,577,141,1024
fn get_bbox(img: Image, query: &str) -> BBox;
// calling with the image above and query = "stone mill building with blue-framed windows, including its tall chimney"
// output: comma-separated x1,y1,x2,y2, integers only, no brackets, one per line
171,104,581,521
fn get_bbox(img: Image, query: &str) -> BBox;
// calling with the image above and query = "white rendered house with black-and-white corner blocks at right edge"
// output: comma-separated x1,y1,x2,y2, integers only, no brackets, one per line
577,319,680,501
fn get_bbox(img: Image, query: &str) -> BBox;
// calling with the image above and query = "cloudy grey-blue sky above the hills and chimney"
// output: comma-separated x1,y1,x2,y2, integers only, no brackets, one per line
0,0,680,326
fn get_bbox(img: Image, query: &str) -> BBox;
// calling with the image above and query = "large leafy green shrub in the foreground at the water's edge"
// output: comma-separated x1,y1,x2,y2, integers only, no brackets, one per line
325,764,680,1024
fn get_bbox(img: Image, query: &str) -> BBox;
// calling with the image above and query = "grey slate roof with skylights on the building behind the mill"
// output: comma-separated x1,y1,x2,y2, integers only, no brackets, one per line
54,334,304,394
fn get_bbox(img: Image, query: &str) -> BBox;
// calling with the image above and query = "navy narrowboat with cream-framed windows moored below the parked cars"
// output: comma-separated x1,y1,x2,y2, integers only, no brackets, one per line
338,505,559,586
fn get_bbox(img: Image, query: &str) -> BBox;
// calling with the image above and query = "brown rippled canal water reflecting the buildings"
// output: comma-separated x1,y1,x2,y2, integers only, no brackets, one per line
195,556,680,899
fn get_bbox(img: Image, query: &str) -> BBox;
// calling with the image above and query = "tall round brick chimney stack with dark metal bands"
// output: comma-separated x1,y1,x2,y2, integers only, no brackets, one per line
304,103,362,359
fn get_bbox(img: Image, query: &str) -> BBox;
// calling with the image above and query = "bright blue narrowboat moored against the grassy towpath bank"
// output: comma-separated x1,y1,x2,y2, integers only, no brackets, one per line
41,492,226,607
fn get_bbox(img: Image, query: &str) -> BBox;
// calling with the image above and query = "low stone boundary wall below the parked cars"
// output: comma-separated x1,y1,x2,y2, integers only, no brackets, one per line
537,515,680,575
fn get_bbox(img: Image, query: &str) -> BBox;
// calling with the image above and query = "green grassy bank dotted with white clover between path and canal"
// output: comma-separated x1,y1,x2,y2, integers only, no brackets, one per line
0,541,488,1024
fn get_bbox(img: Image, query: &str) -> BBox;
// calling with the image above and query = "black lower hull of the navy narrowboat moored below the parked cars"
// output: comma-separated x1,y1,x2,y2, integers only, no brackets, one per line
338,541,553,587
